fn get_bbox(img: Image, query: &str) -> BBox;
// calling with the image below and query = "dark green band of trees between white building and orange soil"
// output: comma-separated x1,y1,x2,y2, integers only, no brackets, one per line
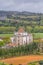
0,43,40,58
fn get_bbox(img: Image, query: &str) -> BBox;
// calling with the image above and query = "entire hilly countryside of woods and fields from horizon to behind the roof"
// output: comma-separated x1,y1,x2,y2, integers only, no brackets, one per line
0,12,43,34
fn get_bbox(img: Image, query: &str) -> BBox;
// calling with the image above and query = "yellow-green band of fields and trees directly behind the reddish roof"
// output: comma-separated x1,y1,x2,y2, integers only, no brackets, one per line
0,25,43,34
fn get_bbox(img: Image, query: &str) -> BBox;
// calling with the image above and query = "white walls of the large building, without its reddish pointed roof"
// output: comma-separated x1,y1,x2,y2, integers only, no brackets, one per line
11,32,33,45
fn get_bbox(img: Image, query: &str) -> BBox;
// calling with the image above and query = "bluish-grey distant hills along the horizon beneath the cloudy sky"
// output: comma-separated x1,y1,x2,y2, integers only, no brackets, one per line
0,11,42,16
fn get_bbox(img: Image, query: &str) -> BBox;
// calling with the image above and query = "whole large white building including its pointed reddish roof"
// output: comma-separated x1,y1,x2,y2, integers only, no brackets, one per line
11,28,33,45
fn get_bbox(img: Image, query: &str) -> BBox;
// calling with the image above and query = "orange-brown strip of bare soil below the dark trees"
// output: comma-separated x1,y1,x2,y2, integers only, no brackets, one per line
0,55,43,65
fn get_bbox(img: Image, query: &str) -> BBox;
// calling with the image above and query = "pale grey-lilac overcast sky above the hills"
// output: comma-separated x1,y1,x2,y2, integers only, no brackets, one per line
0,0,43,13
